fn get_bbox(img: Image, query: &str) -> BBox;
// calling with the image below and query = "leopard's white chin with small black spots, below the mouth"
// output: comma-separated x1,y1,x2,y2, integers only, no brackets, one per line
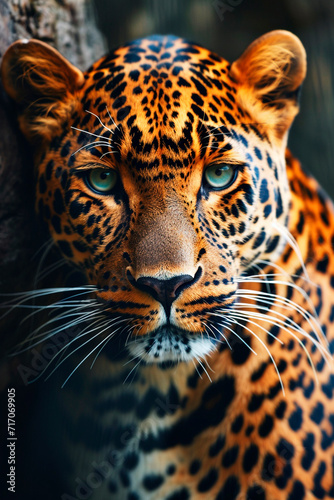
127,325,217,364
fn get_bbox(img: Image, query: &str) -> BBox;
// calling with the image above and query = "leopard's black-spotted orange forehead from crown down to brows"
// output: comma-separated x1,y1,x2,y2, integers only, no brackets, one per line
75,36,244,176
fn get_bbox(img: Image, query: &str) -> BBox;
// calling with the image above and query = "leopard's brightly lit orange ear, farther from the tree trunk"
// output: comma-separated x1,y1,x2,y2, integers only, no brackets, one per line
231,30,306,139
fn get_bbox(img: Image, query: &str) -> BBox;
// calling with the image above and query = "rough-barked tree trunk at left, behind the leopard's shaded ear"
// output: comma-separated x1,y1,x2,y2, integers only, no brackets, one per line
0,0,106,385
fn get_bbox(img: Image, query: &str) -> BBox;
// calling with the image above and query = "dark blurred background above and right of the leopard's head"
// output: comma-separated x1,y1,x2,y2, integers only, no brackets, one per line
94,0,334,197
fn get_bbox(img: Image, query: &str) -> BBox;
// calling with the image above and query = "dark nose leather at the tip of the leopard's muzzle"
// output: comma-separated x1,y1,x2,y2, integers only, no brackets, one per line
135,273,197,316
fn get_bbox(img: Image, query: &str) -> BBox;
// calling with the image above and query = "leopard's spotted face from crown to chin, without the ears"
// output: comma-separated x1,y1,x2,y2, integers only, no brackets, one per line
1,32,306,362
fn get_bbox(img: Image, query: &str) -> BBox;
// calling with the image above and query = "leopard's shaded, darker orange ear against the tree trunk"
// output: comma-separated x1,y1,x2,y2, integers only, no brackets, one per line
1,39,84,142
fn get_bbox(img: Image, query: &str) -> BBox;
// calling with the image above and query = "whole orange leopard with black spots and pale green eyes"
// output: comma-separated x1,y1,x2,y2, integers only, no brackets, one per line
1,30,334,500
